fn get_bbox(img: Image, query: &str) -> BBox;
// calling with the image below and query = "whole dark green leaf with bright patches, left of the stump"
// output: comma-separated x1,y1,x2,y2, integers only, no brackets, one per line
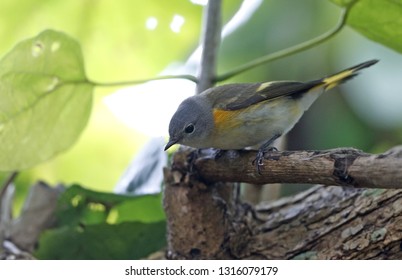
35,185,166,259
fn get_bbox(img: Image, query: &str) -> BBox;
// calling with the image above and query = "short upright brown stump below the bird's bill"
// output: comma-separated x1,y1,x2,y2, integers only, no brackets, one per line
164,148,232,259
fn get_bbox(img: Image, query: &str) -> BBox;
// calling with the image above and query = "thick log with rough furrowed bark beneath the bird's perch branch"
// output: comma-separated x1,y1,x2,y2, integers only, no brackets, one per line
233,186,402,259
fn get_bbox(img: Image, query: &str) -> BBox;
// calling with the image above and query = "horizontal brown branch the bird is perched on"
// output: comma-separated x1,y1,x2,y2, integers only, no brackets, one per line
187,146,402,189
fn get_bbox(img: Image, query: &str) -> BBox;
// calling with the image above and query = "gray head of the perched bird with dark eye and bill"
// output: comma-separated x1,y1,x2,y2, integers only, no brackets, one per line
165,95,214,150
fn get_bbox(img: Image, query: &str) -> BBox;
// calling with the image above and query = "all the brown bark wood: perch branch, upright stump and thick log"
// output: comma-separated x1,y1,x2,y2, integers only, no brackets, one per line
164,148,402,259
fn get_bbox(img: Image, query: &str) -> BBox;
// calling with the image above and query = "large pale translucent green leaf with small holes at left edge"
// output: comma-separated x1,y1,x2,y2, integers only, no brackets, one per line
0,30,93,171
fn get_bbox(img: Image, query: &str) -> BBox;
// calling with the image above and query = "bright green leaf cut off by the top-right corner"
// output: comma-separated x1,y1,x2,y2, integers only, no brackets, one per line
332,0,402,52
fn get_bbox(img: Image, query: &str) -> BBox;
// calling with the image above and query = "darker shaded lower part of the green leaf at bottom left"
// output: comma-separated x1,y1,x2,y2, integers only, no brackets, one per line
35,221,166,260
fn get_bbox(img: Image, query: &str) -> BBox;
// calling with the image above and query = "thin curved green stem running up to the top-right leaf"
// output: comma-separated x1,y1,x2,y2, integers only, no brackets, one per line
215,1,356,82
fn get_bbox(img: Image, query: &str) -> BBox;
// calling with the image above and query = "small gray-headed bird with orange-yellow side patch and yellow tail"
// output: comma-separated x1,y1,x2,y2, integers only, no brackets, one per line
165,60,378,170
